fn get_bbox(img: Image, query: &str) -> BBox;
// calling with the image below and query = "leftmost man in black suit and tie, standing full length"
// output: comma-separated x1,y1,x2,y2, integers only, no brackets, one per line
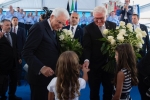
0,19,22,100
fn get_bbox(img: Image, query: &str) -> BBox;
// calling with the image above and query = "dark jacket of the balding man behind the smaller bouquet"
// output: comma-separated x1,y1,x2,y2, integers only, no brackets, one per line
63,25,83,45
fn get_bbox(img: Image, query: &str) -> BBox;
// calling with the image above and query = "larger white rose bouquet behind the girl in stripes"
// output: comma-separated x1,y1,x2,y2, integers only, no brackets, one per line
100,21,147,71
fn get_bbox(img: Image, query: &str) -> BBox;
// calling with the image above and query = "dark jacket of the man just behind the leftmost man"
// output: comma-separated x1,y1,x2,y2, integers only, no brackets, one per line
11,27,26,58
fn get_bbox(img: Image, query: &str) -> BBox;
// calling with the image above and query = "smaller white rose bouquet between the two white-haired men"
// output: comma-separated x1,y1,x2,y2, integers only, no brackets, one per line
57,29,82,57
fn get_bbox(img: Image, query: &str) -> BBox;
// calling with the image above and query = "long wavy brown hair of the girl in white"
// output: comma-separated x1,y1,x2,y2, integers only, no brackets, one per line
56,51,80,100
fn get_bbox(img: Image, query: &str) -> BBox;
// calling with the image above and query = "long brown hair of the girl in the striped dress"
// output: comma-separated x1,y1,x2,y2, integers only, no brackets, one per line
114,43,138,85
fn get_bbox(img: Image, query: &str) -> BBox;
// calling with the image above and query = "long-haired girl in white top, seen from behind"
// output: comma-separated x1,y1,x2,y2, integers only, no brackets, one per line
47,51,89,100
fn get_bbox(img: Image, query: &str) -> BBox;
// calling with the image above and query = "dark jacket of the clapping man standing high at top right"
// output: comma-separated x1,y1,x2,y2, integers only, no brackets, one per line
120,6,133,23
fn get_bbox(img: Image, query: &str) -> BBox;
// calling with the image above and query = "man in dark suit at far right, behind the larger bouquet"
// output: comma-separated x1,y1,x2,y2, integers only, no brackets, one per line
132,14,150,100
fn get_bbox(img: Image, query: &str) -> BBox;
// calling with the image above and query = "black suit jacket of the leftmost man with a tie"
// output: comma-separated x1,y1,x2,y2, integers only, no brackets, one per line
0,32,19,72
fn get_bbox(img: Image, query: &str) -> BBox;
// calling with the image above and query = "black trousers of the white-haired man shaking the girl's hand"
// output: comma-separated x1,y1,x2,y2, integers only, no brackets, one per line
88,69,114,100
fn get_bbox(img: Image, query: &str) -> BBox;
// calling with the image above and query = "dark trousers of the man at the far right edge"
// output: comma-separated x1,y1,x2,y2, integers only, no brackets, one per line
138,73,150,100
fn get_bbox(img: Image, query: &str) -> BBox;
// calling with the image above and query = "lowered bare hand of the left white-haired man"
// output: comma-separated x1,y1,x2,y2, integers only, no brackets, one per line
40,66,54,77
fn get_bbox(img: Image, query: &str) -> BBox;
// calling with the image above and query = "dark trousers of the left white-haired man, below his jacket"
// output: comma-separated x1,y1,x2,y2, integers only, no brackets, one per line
30,84,48,100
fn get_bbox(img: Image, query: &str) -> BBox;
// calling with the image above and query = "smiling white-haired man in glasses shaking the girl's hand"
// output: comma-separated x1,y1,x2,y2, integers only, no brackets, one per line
83,6,116,100
